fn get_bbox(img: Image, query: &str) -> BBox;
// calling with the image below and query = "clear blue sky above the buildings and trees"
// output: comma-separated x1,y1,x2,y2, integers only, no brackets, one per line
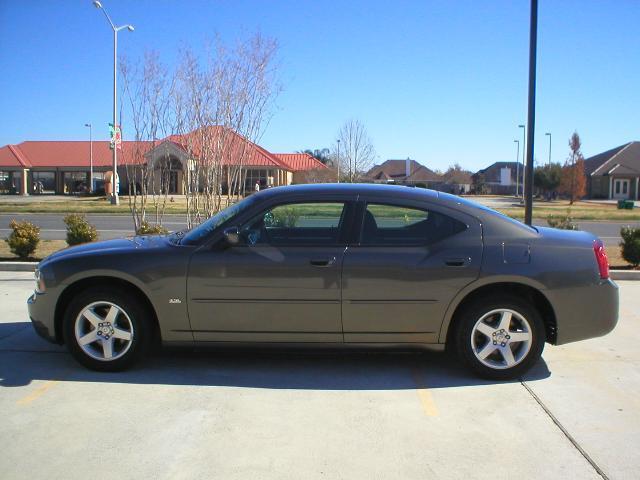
0,0,640,170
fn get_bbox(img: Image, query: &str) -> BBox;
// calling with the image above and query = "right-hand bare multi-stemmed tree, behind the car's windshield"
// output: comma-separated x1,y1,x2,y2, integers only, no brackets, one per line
173,35,279,226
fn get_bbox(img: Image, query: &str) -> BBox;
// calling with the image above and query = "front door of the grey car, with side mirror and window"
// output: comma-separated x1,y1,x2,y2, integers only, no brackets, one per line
188,200,354,342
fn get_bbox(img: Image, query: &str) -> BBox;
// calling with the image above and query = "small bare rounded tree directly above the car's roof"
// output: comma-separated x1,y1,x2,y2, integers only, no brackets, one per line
335,119,376,182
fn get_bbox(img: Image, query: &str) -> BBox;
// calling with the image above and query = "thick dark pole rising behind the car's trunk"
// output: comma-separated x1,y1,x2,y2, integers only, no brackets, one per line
524,0,538,225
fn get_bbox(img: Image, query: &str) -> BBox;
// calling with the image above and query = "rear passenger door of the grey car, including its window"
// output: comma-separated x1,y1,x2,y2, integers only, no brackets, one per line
342,198,482,343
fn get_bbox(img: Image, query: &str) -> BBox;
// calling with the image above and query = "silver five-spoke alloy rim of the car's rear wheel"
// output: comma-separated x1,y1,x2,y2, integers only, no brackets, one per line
471,308,533,370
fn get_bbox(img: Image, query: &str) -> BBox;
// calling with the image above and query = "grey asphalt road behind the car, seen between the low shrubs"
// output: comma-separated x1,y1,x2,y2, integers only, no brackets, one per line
0,213,640,246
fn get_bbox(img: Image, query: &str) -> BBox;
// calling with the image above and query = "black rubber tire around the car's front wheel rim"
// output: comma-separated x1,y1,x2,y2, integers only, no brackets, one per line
63,287,153,372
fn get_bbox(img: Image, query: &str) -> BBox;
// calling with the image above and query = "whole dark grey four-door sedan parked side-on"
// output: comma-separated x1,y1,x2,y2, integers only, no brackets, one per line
28,184,618,379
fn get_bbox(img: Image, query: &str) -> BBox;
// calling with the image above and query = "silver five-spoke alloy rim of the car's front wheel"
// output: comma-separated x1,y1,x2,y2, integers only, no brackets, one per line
75,301,134,362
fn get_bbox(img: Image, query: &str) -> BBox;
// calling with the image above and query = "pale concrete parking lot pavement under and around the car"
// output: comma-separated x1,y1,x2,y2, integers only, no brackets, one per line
0,272,640,479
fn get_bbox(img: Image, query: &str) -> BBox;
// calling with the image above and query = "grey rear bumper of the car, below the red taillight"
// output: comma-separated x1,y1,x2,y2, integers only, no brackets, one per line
546,279,619,345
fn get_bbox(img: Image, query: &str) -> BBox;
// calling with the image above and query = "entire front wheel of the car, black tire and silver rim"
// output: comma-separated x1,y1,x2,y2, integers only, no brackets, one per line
63,288,151,372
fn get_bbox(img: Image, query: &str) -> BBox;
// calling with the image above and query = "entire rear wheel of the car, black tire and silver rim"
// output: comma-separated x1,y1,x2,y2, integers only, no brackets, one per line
455,296,545,380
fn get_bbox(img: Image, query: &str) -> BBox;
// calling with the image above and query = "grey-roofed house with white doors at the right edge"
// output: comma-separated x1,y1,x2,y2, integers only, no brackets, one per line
584,142,640,200
